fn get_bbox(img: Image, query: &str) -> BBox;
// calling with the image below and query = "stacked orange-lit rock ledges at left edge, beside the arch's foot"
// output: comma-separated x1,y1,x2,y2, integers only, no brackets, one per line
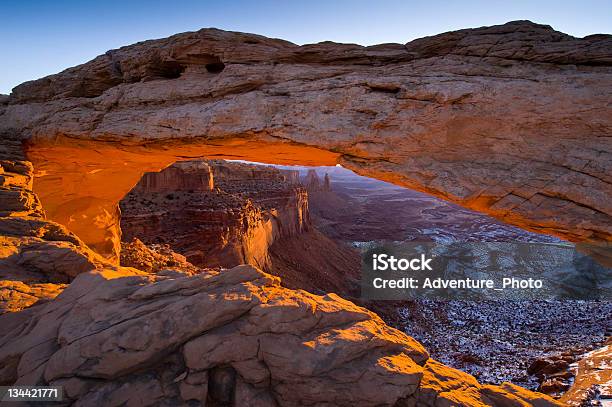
0,160,107,314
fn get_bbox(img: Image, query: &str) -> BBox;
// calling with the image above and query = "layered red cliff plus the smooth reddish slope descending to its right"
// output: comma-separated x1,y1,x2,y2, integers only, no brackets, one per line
120,160,360,296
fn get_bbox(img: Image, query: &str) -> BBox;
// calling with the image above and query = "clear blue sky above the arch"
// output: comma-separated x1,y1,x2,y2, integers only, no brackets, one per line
0,0,612,93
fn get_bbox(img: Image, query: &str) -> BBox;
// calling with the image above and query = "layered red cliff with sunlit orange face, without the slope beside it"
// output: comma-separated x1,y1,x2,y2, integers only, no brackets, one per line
120,160,310,269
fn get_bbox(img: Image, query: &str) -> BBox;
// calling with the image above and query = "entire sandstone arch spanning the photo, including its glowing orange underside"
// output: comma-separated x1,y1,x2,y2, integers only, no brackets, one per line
0,22,612,262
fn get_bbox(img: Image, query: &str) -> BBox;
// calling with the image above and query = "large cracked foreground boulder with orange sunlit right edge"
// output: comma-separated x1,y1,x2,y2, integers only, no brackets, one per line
0,266,556,406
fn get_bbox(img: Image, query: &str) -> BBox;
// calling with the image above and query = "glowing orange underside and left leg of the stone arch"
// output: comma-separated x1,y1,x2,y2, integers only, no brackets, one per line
26,138,339,260
